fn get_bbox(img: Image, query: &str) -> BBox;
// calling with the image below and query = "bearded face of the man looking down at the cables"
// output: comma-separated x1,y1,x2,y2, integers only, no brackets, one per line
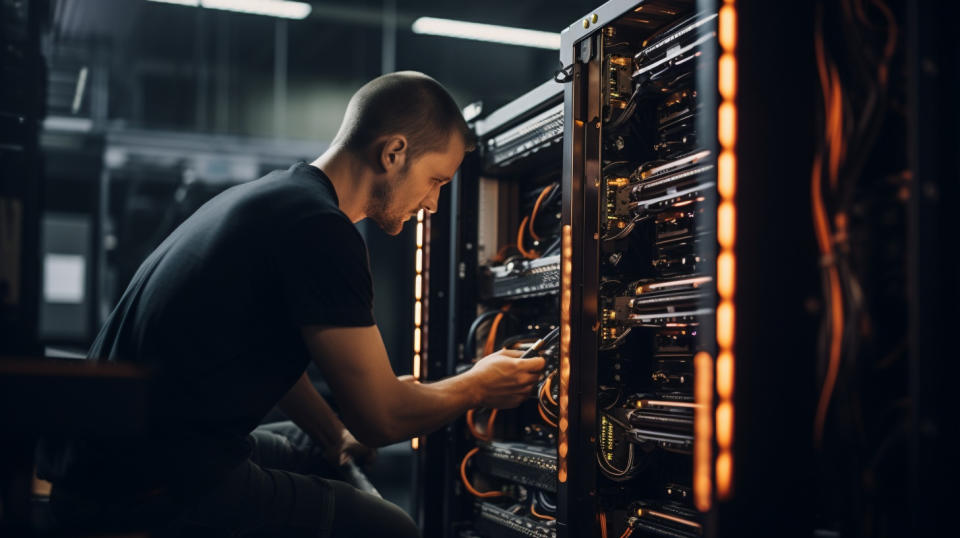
367,134,465,235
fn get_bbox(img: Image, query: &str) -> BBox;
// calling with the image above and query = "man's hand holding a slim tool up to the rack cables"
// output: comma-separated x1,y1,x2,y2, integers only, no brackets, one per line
469,349,546,409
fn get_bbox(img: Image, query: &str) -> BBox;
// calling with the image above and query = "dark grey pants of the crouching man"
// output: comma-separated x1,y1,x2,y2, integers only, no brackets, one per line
51,422,420,538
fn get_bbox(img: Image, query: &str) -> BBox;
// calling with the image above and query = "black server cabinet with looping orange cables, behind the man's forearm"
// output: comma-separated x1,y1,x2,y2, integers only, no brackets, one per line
412,81,563,537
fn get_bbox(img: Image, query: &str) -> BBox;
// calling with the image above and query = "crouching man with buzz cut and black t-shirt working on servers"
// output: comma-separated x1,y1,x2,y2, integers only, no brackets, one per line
39,72,544,537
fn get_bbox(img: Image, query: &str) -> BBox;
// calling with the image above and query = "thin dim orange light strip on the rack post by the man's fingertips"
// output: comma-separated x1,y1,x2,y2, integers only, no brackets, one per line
557,224,573,482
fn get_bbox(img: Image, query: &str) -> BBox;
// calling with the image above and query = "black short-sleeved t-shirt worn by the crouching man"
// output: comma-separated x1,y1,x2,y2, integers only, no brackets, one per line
38,163,374,487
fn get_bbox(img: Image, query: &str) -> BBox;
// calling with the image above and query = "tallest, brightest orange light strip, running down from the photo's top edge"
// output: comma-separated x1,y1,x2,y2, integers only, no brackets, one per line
714,0,737,500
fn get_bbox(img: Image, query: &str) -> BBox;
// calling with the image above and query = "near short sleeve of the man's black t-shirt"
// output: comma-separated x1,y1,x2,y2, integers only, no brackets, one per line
274,214,374,327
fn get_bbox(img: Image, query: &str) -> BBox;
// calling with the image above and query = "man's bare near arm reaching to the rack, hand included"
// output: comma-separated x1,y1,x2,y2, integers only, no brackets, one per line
302,326,544,446
